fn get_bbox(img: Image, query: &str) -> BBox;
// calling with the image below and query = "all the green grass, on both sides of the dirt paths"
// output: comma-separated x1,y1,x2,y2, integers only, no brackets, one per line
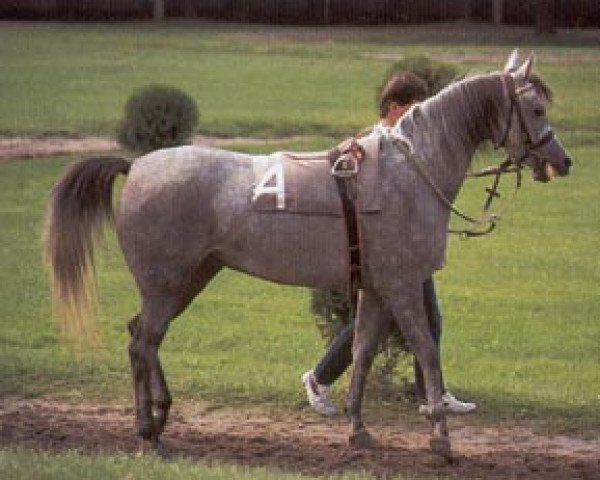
0,23,600,478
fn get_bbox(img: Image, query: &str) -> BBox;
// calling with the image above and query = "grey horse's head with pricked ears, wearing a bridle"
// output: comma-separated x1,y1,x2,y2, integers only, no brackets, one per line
498,50,572,182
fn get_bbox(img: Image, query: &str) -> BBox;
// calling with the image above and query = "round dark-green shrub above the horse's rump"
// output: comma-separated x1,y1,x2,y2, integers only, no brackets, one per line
117,85,199,154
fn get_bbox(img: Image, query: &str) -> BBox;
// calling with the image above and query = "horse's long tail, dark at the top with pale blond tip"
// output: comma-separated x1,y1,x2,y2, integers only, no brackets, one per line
44,157,131,342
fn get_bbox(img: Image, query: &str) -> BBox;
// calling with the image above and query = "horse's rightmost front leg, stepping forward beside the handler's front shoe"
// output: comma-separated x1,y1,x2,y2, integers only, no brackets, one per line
386,285,452,461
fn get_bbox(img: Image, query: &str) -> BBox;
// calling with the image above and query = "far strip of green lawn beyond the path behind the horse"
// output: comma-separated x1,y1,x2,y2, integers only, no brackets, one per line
0,23,600,137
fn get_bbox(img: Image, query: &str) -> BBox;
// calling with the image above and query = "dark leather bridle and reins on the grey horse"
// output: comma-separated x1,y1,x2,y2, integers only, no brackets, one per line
395,72,554,238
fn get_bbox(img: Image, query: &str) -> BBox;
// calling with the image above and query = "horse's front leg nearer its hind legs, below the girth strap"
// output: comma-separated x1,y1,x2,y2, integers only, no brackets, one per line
346,291,390,448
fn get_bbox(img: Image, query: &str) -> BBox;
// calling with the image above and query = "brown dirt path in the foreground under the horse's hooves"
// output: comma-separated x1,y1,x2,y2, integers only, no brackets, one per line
0,398,600,480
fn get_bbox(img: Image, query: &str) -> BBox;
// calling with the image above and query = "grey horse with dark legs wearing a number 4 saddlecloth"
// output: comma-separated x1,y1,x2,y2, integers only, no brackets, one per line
45,53,571,459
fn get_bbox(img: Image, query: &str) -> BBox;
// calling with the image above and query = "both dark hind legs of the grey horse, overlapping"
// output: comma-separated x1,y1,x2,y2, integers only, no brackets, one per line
129,259,221,451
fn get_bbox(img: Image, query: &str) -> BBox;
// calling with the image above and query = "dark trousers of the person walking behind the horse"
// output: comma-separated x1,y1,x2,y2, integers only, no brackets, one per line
313,278,443,397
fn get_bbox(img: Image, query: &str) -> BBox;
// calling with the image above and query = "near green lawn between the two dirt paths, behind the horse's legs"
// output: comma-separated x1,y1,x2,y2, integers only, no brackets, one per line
0,143,600,430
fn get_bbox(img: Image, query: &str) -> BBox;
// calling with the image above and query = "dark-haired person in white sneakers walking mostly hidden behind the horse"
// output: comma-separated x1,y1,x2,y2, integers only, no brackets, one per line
302,72,477,416
